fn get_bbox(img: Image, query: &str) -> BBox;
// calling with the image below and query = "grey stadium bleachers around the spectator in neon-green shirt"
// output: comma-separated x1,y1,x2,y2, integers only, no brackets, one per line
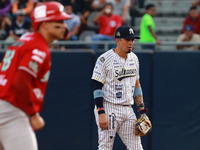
133,0,195,50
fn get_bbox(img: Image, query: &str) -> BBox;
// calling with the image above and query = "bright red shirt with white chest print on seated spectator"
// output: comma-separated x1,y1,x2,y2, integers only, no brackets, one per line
99,14,122,36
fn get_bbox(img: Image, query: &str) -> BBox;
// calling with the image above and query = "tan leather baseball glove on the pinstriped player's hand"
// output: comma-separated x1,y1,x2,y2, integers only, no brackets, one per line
134,113,152,136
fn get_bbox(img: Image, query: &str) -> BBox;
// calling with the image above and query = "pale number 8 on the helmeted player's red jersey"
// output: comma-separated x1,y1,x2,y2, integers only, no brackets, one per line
1,50,15,71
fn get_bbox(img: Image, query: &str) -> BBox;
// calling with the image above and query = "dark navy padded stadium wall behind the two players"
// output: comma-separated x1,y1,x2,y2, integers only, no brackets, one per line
0,51,200,150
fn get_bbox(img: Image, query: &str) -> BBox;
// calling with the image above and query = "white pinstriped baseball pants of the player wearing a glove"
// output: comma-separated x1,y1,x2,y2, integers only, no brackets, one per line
94,101,143,150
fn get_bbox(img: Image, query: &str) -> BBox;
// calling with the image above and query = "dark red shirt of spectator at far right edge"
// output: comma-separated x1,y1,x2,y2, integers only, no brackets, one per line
182,15,200,34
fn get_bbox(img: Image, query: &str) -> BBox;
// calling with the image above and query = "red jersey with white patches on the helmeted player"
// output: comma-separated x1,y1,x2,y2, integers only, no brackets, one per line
0,32,51,114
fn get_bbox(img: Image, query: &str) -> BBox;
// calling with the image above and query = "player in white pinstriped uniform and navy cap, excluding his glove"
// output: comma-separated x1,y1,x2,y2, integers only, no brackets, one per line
92,26,151,150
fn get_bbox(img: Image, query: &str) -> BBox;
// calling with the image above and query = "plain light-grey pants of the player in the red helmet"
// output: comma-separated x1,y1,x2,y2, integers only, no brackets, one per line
0,100,38,150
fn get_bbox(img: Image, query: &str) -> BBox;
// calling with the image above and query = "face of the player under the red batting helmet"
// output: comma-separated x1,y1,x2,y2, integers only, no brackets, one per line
47,20,67,40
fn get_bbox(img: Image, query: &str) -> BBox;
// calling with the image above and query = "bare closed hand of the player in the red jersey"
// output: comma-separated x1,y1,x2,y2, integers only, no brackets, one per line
30,112,45,131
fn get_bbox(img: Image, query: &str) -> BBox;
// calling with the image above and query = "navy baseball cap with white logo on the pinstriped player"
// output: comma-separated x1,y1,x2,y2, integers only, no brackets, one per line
115,26,140,39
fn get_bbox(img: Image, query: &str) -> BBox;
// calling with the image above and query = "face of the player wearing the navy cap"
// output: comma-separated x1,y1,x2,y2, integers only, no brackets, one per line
119,38,134,53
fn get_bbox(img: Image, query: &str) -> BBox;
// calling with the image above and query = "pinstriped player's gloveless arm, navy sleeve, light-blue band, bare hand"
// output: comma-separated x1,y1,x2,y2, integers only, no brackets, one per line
92,80,108,130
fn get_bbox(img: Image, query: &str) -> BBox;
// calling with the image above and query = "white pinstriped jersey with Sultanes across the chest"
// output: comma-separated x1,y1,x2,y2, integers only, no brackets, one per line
92,49,139,105
